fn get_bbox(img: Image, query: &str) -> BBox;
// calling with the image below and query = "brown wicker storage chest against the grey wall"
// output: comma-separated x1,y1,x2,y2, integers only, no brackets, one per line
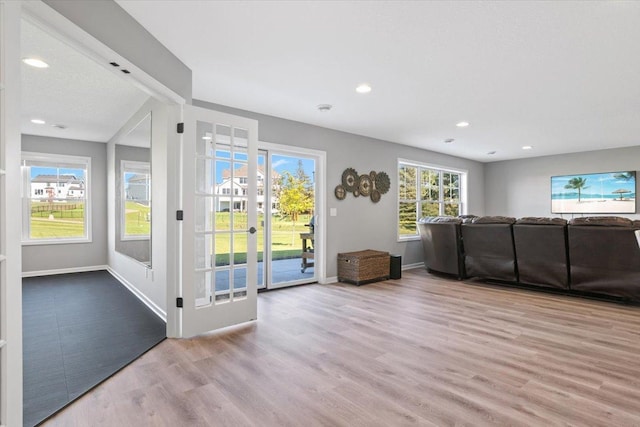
338,249,389,285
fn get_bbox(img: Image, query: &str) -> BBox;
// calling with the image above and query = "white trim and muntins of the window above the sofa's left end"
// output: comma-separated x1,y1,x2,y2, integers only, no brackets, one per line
396,158,468,242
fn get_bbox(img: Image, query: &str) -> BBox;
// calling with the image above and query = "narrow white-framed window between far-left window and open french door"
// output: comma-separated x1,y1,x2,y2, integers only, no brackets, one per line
120,160,151,240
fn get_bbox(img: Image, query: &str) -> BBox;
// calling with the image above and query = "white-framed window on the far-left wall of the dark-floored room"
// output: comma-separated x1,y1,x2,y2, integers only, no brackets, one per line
22,152,91,244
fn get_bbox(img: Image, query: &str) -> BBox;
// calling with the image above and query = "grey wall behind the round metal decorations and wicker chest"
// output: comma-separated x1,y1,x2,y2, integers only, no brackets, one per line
193,100,485,277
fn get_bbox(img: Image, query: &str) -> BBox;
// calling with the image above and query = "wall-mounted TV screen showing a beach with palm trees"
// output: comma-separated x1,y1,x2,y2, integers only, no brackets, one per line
551,171,636,213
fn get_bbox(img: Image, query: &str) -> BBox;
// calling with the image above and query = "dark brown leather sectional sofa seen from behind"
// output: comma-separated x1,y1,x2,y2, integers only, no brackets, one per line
418,216,640,301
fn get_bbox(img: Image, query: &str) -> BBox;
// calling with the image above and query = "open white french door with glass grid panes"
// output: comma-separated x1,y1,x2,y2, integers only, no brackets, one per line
180,105,258,337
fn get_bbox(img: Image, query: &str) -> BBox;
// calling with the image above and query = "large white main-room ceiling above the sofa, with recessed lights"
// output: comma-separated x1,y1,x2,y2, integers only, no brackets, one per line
117,0,640,162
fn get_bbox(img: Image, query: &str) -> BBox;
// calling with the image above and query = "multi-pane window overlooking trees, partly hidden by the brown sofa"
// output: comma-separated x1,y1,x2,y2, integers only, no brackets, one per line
398,160,467,240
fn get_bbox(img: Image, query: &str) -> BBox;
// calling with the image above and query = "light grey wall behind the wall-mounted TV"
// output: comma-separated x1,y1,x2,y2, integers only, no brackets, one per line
485,146,640,219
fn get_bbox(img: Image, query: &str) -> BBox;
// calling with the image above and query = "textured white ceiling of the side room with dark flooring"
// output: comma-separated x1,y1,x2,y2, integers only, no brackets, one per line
20,20,149,142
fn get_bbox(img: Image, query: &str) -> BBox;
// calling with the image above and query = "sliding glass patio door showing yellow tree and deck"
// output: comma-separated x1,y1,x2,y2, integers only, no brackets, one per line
258,144,323,289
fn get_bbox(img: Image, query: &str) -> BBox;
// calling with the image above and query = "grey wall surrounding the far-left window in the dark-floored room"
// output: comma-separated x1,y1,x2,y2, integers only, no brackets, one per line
18,135,107,273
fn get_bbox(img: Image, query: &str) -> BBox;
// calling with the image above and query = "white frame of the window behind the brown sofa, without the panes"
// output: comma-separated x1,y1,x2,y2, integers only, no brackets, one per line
396,158,469,242
